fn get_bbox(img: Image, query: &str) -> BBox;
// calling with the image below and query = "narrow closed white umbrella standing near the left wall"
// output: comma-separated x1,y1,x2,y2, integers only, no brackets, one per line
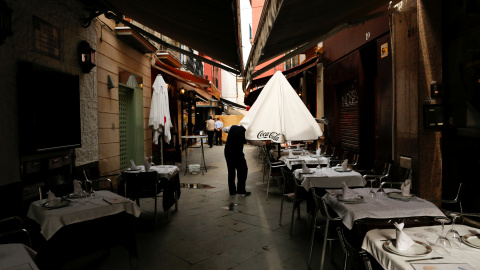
148,74,173,164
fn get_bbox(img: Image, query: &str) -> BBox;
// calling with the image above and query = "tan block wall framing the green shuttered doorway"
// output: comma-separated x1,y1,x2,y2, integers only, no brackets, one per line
95,16,153,178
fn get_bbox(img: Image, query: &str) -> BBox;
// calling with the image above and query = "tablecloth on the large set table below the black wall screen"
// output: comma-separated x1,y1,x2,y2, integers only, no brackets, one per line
27,190,140,240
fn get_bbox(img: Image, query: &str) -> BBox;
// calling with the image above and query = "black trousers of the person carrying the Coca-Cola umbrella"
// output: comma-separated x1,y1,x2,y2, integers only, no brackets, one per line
225,153,248,195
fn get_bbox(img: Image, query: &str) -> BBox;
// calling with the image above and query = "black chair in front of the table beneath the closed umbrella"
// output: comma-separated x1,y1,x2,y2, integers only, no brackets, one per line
122,171,165,226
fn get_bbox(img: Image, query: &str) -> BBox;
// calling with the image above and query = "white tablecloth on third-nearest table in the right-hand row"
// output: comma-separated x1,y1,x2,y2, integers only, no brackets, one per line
293,167,366,190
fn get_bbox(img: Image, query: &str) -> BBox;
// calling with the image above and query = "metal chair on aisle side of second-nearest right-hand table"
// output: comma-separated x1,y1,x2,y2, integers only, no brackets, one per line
308,188,347,270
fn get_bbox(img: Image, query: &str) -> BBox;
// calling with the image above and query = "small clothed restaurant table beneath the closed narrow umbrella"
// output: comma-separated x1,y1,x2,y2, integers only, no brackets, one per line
117,165,181,212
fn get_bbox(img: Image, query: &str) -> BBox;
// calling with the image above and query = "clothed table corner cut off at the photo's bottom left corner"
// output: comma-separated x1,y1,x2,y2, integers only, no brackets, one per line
0,244,38,270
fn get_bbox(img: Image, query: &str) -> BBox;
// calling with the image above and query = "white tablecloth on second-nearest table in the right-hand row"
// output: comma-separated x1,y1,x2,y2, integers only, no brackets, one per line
323,188,444,230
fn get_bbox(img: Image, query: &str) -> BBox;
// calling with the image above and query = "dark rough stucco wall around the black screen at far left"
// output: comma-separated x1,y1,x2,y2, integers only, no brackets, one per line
0,0,97,185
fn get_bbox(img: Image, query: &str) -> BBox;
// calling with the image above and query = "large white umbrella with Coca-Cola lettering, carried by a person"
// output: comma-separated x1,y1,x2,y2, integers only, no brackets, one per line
239,71,323,143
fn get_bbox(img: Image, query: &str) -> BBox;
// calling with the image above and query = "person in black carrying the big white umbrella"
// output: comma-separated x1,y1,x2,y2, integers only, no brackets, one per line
223,125,251,196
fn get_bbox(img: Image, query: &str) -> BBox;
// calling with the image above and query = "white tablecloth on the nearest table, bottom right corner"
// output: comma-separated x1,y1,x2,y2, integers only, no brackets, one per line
362,225,480,270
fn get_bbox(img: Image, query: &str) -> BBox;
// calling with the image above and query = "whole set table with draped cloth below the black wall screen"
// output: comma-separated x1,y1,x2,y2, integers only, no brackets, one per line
27,190,140,269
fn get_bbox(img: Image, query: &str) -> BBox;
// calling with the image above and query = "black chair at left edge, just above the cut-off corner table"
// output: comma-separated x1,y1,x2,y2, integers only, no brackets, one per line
0,216,32,247
